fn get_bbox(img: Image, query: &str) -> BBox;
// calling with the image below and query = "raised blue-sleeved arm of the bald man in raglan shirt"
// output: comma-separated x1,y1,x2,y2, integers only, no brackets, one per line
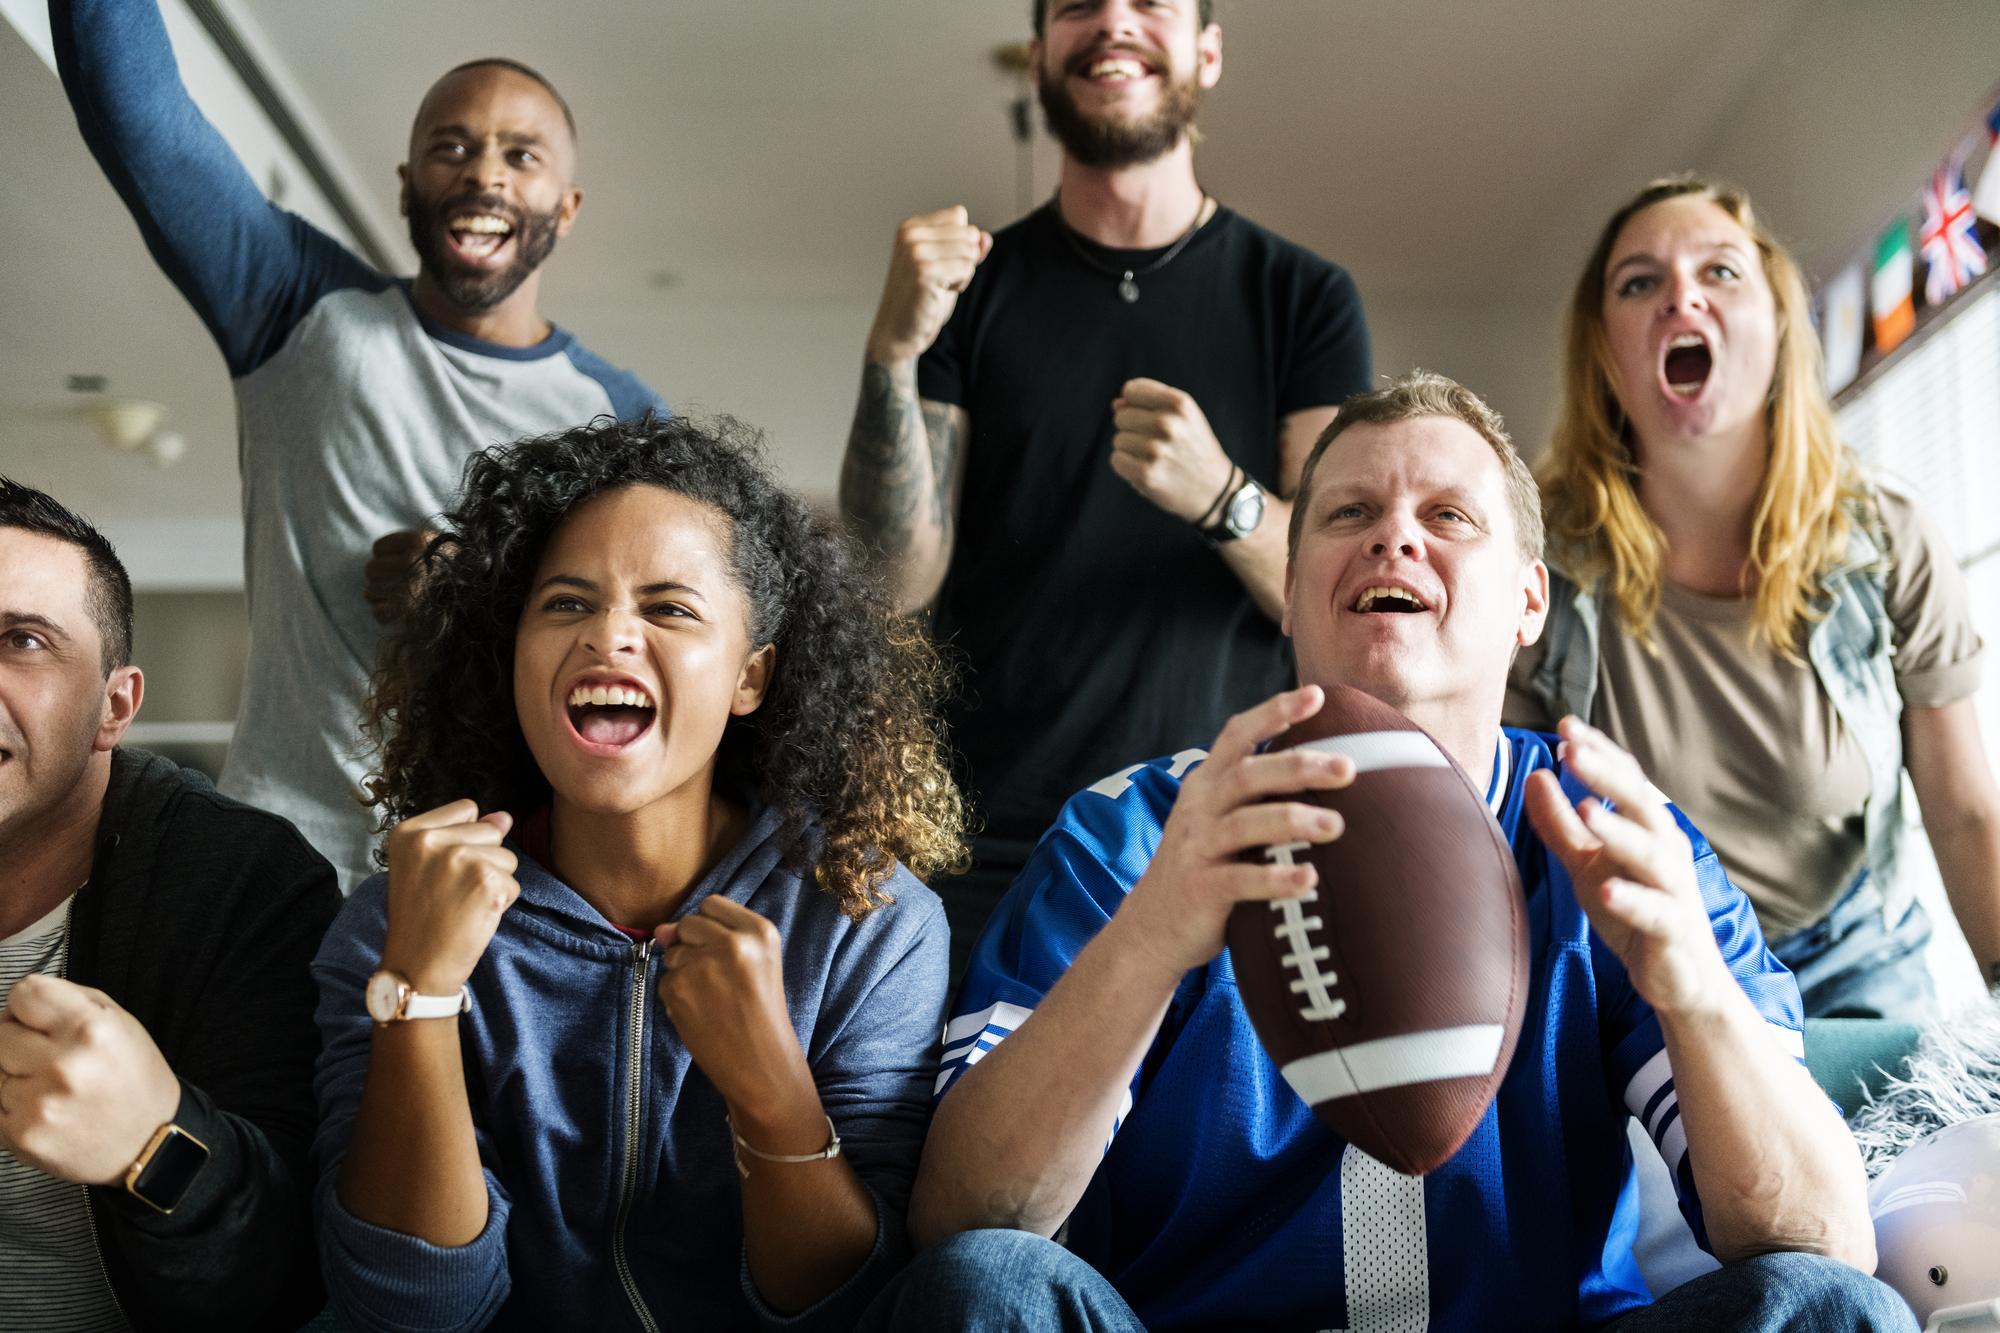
48,0,376,376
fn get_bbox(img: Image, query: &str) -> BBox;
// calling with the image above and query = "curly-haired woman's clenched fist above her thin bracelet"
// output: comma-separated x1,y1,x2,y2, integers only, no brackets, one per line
654,895,812,1115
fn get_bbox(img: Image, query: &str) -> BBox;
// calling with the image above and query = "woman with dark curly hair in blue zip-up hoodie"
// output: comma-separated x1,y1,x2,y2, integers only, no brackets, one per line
314,420,964,1329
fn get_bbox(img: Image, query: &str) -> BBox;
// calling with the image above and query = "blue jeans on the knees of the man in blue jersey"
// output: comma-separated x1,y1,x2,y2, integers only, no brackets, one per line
854,1231,1916,1333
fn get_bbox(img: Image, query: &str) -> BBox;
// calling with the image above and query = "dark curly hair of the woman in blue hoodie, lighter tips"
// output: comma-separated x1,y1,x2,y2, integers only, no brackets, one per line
362,414,968,917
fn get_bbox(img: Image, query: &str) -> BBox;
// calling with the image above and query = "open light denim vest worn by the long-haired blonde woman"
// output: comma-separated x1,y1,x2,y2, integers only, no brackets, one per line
1534,522,1916,927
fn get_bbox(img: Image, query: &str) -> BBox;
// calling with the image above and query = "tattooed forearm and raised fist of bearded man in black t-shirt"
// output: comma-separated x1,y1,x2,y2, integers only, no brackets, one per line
840,208,992,612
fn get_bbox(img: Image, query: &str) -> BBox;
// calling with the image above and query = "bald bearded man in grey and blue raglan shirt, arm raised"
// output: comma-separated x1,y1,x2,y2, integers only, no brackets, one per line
48,0,666,889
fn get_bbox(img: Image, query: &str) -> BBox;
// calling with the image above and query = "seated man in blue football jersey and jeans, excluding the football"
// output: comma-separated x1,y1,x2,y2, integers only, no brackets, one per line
862,374,1916,1333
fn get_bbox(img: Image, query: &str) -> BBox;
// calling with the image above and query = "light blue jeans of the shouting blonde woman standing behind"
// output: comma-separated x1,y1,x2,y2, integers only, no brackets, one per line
1770,871,1938,1023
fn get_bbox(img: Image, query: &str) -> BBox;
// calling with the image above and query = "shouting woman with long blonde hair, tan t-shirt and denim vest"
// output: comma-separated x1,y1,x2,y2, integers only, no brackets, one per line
1506,176,2000,1021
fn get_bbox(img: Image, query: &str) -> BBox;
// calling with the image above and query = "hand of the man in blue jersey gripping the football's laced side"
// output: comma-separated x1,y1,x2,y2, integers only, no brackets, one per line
1118,685,1354,977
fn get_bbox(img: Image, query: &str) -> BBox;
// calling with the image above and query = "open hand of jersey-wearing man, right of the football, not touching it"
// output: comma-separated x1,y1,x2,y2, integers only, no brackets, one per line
1528,717,1734,1013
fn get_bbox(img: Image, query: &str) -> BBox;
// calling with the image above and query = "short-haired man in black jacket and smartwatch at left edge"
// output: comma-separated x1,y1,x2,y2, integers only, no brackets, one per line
0,478,340,1329
